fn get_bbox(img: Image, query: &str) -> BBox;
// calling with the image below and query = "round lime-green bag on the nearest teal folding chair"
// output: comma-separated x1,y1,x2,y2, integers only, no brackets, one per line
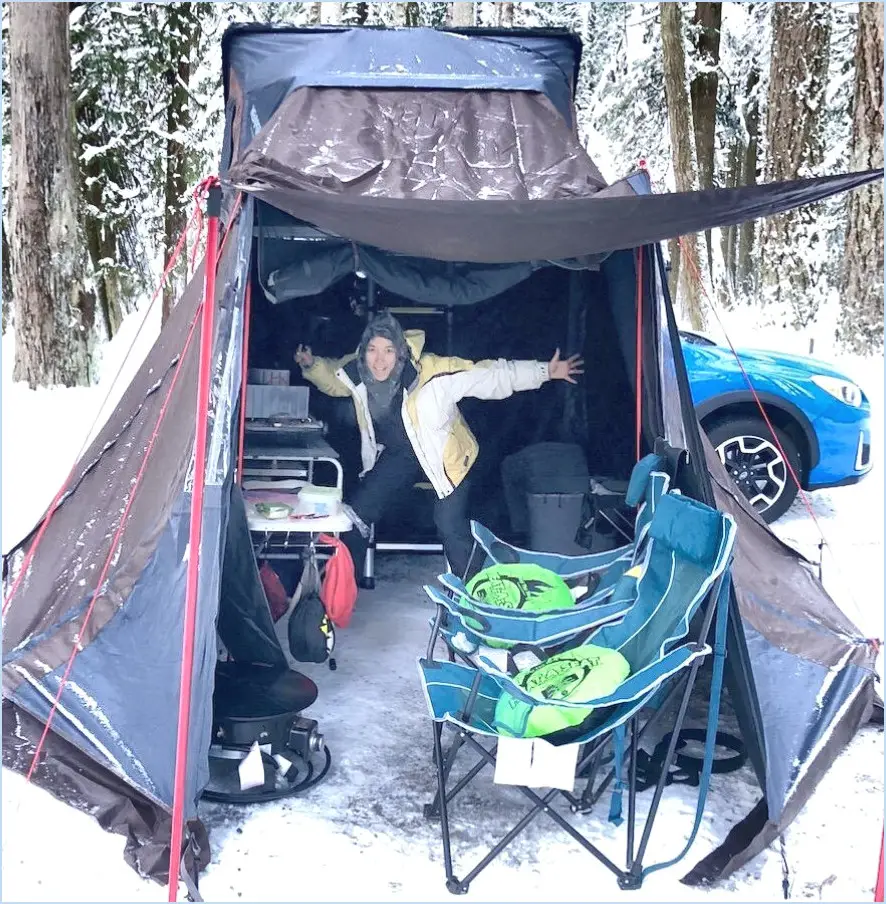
493,644,631,738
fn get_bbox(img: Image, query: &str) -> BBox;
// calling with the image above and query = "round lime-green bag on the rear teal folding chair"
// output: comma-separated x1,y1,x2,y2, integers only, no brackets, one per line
462,563,575,647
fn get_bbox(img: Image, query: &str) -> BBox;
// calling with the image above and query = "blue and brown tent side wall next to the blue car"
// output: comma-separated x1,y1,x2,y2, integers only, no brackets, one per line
657,250,877,885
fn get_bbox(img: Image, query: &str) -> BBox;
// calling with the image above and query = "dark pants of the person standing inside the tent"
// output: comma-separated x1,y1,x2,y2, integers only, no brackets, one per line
343,448,474,578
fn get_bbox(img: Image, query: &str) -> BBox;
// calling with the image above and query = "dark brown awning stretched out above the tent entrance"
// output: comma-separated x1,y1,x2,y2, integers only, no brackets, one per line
225,159,883,263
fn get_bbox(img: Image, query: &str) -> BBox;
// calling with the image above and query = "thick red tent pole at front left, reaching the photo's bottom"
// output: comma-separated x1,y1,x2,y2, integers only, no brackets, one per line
168,179,221,901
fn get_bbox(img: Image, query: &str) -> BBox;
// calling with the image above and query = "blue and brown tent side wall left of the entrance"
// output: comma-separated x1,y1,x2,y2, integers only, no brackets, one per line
3,205,258,860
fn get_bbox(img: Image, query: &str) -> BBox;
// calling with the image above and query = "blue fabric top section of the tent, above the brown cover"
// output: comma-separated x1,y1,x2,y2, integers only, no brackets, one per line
222,25,581,164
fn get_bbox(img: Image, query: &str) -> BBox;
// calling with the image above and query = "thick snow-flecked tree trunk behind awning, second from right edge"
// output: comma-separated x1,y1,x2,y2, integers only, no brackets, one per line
760,3,831,328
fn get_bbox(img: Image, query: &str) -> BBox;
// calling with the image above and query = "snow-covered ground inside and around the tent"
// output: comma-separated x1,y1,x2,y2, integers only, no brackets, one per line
2,300,884,901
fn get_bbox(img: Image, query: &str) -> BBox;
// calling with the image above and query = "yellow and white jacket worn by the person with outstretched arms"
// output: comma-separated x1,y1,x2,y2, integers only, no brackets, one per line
302,330,550,499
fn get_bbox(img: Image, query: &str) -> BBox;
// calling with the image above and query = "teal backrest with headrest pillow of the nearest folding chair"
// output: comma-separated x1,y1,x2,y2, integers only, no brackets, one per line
592,493,735,671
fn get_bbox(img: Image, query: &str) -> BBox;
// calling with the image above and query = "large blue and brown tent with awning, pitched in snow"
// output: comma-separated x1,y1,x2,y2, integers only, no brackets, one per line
3,26,882,881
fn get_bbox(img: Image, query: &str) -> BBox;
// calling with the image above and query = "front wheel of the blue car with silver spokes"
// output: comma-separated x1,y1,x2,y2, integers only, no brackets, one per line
705,417,803,524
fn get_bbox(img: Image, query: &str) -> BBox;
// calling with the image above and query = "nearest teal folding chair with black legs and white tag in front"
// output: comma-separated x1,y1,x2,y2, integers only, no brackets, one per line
419,494,735,894
